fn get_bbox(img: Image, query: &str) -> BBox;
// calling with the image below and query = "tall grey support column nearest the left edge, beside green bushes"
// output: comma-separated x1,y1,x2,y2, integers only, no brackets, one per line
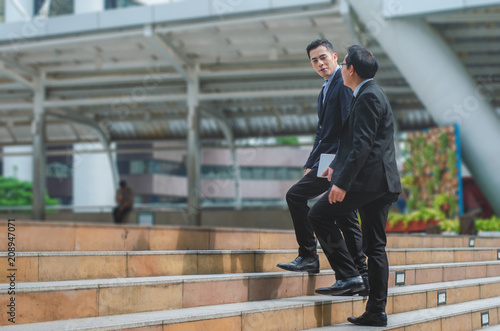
31,74,46,220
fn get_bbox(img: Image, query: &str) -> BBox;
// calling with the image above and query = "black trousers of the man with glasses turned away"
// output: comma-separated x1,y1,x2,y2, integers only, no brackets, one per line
309,192,398,312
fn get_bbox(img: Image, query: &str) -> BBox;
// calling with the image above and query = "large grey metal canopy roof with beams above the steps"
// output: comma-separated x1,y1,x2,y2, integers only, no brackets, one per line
0,1,500,145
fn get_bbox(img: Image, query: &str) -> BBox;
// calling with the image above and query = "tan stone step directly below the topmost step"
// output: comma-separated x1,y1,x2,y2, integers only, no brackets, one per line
0,247,499,283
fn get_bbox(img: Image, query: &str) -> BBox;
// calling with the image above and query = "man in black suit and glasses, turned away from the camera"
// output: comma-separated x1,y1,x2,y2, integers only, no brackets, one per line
308,45,401,326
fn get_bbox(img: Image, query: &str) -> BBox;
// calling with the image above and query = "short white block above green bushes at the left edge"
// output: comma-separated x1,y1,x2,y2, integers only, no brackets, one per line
3,146,33,182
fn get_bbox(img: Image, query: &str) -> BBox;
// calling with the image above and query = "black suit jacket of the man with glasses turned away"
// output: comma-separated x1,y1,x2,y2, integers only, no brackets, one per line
331,80,401,193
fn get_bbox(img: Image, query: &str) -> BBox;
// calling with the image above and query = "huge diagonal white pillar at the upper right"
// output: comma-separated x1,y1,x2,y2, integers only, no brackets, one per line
349,0,500,214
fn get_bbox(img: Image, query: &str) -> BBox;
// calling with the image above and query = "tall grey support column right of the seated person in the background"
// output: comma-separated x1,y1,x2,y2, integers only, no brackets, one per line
187,69,201,226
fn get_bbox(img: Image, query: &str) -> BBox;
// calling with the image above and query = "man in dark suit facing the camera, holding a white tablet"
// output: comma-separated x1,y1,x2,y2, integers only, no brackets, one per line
278,39,368,295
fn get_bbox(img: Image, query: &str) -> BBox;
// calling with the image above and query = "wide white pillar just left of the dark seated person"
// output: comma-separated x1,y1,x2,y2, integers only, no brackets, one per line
73,143,115,212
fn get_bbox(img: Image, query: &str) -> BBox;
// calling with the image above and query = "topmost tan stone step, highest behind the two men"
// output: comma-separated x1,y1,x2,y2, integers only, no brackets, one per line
0,220,500,252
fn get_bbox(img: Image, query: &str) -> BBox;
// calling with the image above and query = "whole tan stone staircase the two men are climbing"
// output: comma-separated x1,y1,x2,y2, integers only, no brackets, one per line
0,221,500,331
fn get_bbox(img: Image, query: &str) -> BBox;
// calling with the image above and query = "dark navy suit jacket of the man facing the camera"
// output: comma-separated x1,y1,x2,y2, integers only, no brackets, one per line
304,69,352,168
